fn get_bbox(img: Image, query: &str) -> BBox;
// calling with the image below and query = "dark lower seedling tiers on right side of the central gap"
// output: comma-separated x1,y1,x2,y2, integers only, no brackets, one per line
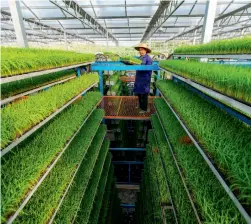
136,130,175,224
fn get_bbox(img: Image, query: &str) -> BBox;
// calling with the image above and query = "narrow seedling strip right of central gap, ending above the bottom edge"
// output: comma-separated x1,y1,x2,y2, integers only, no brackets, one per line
148,130,170,206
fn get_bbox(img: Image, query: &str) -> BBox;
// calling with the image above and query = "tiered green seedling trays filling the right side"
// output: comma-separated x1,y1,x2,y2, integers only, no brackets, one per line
155,39,251,223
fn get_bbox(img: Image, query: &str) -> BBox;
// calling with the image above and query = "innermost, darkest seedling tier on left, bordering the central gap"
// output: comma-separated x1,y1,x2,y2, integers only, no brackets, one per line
98,175,116,224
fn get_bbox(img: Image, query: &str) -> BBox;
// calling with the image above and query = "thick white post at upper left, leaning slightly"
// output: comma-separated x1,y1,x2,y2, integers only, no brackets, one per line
9,0,29,47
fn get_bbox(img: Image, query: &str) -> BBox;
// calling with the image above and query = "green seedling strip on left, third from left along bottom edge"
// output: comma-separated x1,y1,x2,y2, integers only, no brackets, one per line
54,121,106,223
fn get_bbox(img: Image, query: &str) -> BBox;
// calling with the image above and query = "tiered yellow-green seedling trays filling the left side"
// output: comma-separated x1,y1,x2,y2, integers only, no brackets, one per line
1,47,119,223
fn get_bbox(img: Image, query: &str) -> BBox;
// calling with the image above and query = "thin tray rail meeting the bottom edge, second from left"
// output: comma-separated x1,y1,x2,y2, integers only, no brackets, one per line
48,126,104,224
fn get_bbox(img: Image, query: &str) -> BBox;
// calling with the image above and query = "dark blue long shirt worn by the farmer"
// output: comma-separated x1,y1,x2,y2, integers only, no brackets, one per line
133,54,152,94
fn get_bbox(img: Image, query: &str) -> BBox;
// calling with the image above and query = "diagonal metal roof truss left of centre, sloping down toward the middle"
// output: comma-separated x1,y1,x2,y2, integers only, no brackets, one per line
50,0,118,45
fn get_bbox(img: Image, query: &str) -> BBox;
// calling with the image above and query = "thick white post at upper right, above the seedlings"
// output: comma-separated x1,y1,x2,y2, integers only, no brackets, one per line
201,0,217,44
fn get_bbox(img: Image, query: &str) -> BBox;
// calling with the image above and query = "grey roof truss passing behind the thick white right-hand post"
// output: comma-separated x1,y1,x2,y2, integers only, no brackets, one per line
166,3,251,42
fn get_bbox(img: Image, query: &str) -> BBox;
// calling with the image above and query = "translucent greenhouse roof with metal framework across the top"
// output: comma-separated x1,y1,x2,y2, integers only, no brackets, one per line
1,0,251,45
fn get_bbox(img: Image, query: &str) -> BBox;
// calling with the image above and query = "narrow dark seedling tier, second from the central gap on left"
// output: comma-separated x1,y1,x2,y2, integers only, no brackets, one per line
88,165,114,224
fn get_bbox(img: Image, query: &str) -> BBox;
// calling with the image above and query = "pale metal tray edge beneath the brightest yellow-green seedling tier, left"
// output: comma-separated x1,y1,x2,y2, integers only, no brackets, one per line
1,83,97,157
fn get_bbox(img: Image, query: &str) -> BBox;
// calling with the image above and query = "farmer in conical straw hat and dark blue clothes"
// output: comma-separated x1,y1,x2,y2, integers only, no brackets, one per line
133,43,152,113
